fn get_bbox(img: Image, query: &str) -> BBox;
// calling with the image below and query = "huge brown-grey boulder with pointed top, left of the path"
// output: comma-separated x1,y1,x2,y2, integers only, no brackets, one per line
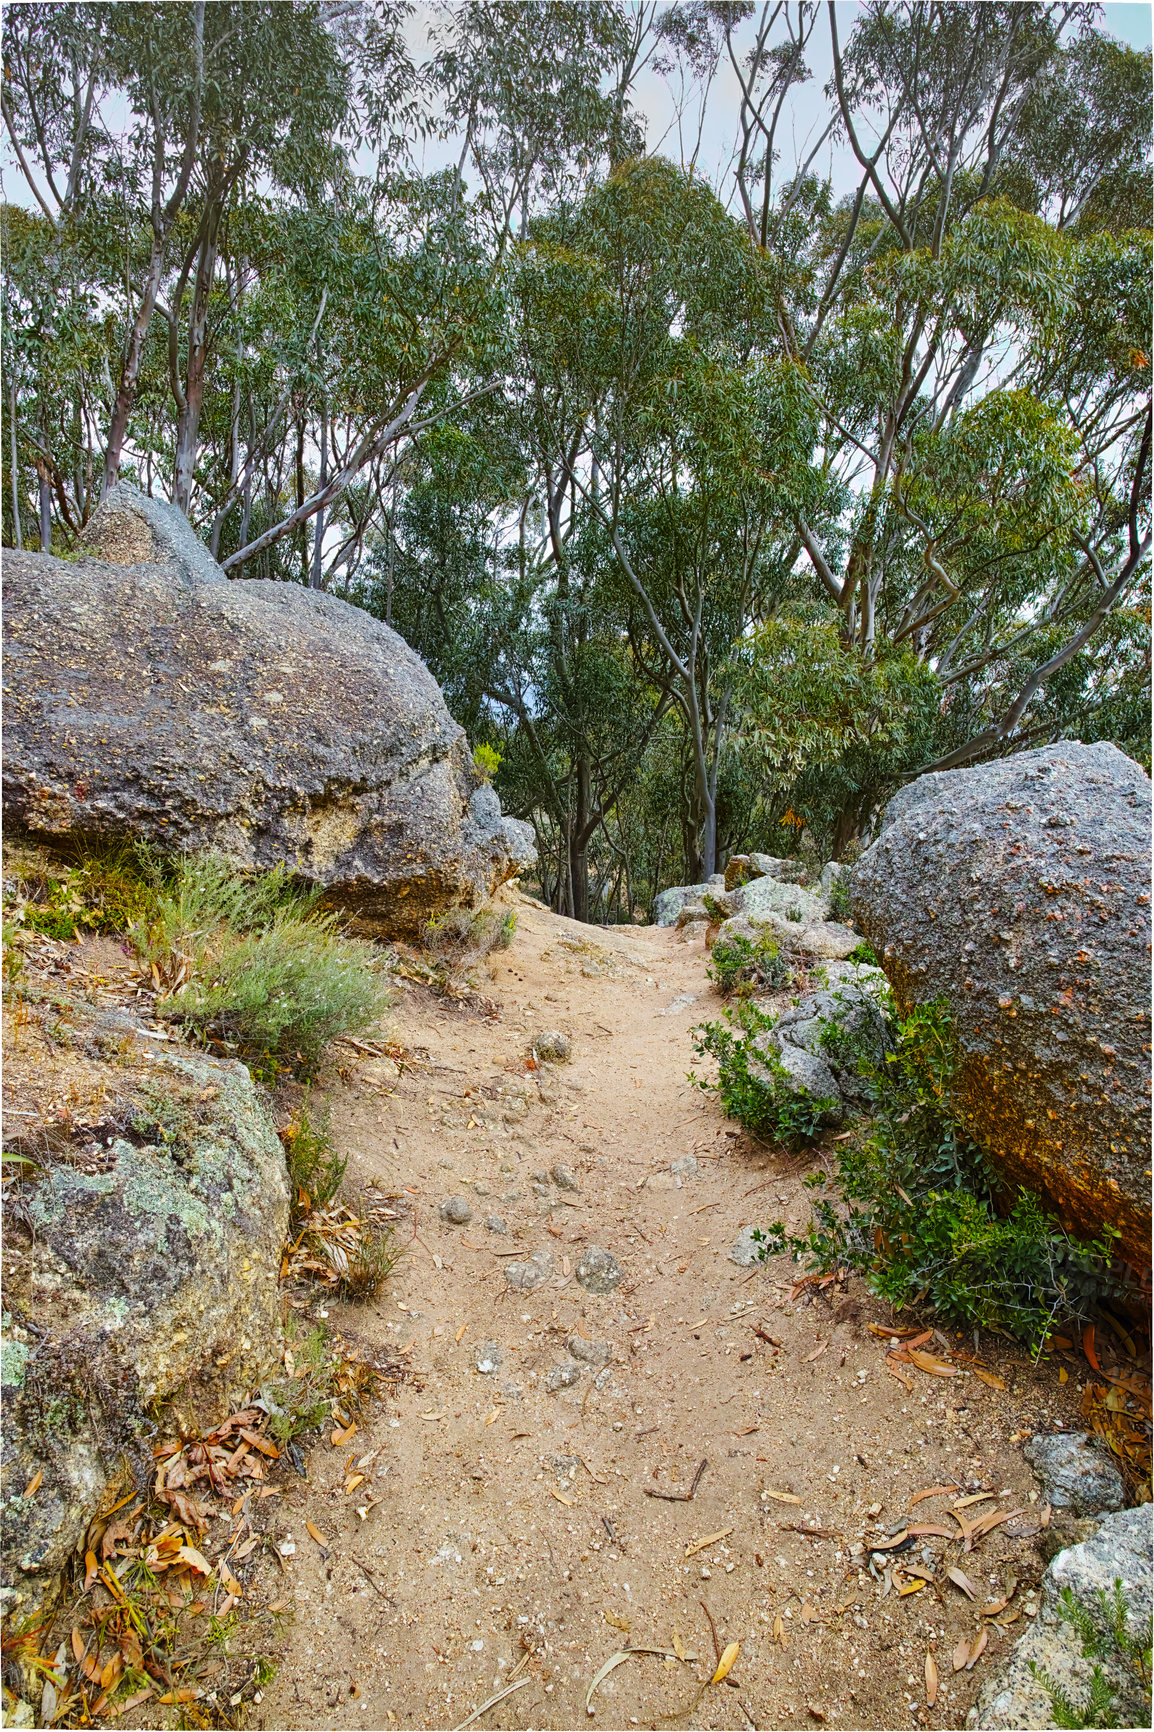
3,488,535,937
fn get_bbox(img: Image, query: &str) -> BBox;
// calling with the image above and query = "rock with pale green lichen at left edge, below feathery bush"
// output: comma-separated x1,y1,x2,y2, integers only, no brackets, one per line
0,1003,289,1616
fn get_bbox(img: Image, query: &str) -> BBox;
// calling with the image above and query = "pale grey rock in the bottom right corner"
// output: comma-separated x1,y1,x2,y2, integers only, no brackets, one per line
965,1503,1151,1732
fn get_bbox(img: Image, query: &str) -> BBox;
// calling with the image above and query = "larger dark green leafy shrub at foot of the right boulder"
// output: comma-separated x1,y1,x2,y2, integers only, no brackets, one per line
741,1005,1119,1347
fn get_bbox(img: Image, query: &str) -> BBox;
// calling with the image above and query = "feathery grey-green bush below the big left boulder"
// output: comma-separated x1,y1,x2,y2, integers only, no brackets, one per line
132,854,386,1072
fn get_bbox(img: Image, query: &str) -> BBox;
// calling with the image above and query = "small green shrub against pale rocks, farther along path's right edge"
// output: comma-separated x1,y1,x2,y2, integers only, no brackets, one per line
690,1003,835,1147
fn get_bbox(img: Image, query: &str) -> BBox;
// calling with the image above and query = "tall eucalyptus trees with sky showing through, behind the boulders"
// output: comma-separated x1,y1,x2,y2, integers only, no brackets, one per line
2,0,1152,920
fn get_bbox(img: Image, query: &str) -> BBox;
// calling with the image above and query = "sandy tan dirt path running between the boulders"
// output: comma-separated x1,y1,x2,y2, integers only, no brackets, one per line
251,901,1076,1729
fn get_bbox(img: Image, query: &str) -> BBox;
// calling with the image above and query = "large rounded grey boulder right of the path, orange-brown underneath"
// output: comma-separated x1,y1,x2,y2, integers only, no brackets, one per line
851,743,1151,1268
